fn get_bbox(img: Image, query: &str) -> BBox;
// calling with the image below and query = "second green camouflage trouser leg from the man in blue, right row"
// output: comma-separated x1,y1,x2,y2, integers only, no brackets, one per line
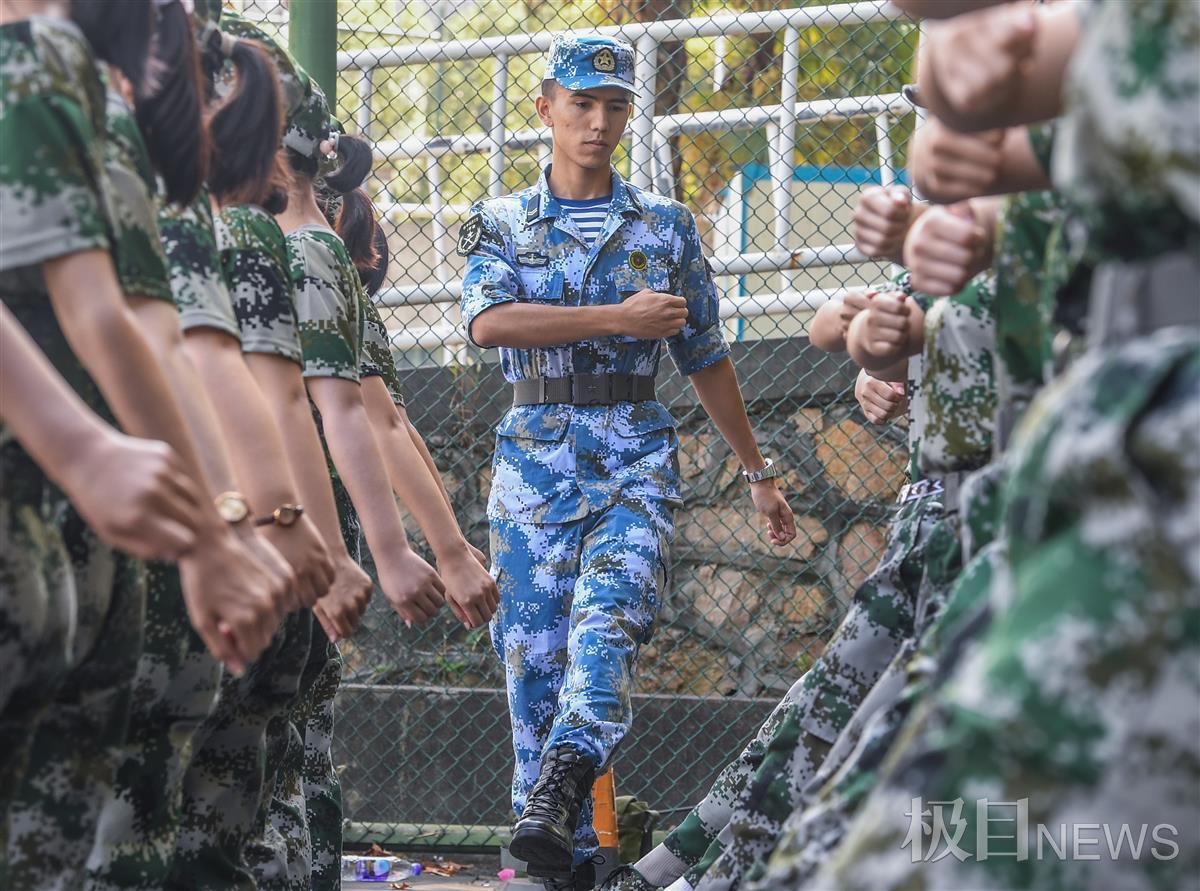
745,464,1003,891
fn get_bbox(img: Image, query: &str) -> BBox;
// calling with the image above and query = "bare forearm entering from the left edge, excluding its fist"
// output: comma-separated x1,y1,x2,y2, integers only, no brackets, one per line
0,304,104,484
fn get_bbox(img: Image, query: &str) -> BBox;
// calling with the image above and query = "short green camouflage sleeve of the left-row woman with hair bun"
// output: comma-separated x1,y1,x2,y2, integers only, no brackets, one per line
287,227,362,382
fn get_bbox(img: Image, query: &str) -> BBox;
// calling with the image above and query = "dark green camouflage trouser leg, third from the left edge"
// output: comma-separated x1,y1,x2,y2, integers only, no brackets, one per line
86,563,221,891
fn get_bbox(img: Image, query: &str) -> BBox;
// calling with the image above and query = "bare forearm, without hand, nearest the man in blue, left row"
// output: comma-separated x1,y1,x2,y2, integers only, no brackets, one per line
362,377,467,561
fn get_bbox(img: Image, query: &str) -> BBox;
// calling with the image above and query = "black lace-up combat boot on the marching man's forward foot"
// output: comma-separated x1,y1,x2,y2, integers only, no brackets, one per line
509,746,595,879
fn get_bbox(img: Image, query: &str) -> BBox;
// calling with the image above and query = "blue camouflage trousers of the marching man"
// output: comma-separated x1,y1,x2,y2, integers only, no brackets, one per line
491,497,677,862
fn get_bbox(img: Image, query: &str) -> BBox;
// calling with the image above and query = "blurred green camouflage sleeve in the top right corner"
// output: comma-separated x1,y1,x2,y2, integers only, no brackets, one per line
1052,0,1200,259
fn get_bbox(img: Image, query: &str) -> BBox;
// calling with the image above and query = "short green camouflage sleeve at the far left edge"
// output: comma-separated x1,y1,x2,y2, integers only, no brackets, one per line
0,20,109,270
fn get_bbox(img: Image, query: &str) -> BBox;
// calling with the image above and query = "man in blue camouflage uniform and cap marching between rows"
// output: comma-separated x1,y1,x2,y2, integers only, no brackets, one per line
458,35,794,887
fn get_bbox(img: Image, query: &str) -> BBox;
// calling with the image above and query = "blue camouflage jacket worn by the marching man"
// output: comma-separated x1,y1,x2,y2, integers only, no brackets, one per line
458,168,728,522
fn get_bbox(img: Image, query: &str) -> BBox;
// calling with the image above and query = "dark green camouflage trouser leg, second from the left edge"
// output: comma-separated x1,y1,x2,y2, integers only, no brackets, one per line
0,508,145,891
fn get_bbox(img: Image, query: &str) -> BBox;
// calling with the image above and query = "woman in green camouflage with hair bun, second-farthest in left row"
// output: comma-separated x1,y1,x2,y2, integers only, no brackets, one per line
276,69,456,889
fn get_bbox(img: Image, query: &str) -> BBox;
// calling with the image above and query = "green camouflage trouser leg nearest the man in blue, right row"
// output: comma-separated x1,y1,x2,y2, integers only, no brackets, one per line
606,497,941,890
